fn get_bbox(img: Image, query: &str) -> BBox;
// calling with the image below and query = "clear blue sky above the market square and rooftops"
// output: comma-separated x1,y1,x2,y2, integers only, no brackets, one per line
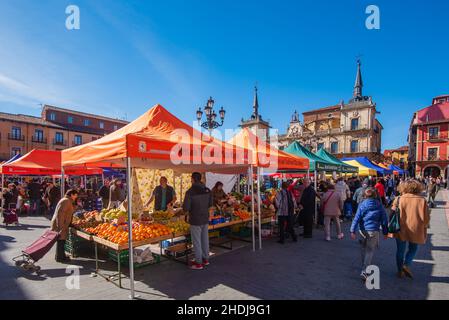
0,0,449,148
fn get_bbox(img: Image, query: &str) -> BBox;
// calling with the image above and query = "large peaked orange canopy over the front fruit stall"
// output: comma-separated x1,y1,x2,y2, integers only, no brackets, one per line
62,105,249,173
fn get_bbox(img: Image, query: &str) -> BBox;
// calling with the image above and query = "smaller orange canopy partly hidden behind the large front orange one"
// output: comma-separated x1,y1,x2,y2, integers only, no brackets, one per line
228,128,310,172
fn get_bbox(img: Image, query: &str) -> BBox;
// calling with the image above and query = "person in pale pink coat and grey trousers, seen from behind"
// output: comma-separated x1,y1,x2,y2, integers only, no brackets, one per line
322,183,344,241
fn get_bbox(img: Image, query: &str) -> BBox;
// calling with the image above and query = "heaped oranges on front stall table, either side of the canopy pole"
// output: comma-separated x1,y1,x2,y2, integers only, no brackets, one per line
86,223,172,244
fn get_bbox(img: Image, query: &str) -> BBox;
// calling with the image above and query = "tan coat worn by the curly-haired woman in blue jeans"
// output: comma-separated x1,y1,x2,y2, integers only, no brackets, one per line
392,194,430,244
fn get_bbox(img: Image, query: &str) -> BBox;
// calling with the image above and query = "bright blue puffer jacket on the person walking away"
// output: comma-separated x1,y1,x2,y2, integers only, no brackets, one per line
351,199,388,235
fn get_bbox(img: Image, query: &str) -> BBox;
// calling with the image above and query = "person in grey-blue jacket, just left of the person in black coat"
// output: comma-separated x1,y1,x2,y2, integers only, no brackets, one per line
275,181,298,244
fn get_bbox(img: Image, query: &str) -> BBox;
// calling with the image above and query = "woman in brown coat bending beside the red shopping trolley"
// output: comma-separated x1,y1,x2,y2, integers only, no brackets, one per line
51,189,78,263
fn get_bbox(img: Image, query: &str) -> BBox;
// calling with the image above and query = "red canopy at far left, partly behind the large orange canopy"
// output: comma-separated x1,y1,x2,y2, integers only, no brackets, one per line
2,149,102,176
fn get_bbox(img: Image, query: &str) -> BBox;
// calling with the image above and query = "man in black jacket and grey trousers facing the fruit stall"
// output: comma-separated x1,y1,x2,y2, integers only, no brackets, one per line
183,172,213,270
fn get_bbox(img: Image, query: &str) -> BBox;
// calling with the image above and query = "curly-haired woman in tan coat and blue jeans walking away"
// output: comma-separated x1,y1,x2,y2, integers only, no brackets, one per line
392,180,430,278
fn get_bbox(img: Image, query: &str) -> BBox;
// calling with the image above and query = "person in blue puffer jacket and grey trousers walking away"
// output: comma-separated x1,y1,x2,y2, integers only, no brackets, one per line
350,188,388,280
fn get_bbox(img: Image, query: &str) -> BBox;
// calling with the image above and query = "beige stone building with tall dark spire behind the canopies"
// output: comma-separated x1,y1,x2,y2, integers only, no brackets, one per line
272,61,383,159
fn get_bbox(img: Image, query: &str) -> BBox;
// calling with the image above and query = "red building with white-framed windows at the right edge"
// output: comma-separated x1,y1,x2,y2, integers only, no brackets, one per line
409,95,449,177
